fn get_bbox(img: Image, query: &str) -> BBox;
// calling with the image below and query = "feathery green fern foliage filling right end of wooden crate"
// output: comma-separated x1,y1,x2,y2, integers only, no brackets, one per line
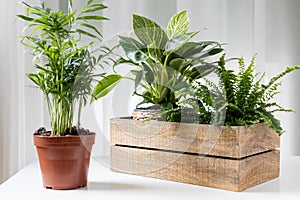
183,55,300,135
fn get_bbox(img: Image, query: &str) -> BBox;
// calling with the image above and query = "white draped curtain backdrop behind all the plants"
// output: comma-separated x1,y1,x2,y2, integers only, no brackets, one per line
0,0,300,183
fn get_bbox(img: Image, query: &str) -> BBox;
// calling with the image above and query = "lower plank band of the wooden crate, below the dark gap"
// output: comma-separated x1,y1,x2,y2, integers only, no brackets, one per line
111,146,280,191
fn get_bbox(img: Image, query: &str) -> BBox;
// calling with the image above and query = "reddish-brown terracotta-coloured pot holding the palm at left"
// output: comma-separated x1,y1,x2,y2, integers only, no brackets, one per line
34,133,95,190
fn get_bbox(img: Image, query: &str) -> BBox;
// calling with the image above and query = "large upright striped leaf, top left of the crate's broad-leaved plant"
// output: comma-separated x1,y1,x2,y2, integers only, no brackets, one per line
132,14,168,49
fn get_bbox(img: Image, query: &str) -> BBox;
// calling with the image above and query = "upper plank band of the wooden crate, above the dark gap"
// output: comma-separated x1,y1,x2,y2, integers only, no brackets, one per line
110,118,280,158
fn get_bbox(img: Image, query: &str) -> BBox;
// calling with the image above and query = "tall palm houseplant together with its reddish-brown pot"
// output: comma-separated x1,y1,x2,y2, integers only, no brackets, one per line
17,0,121,189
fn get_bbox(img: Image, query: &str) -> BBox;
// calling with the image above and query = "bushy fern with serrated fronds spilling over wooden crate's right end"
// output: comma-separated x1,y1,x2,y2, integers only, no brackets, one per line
198,55,300,135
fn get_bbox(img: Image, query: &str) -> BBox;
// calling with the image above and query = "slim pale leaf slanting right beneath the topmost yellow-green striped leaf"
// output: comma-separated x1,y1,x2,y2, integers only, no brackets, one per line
166,31,199,53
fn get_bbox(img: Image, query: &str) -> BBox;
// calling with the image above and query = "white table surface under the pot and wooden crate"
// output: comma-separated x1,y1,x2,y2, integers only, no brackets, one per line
0,157,300,200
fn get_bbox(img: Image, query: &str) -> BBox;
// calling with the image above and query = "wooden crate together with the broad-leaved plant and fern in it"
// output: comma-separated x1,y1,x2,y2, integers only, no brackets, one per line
111,12,300,191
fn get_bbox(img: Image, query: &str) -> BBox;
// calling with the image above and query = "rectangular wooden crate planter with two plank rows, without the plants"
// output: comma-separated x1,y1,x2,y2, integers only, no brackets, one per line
110,118,280,191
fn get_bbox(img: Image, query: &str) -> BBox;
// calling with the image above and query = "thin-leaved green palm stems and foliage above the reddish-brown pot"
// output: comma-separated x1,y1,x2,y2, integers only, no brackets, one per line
17,0,121,136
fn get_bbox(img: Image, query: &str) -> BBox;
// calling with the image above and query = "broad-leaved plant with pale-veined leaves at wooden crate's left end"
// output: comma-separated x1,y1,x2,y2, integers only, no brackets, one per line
116,11,223,121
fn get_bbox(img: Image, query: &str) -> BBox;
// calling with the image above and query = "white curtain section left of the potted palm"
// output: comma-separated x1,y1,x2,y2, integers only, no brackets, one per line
0,0,50,183
